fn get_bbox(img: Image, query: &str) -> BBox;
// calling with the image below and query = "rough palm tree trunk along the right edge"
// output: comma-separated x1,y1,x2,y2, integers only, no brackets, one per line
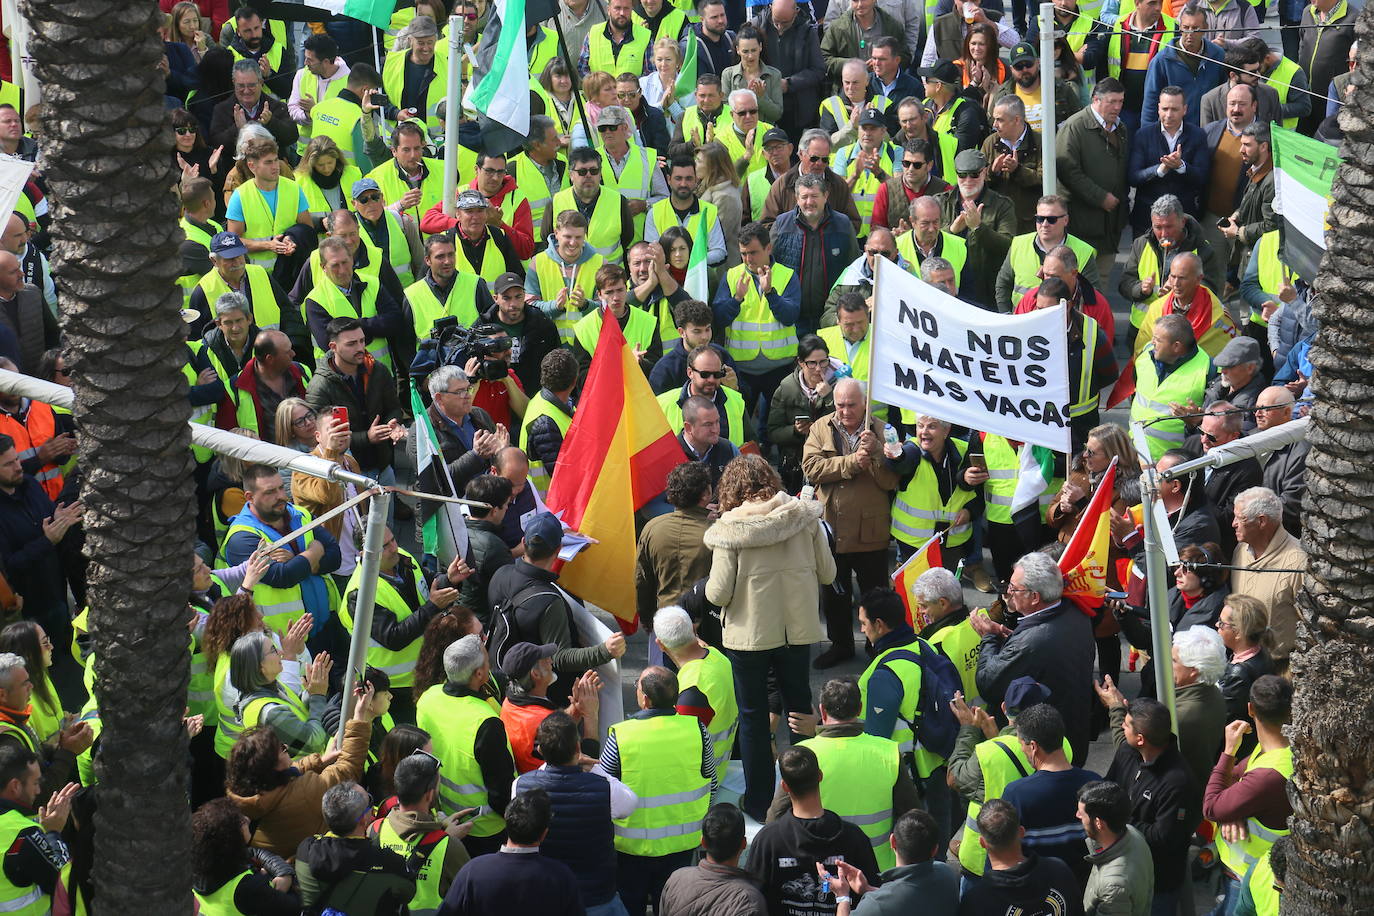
1283,10,1374,915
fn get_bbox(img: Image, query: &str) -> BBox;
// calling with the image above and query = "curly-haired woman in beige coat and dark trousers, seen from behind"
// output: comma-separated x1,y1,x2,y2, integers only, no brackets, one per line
702,455,835,821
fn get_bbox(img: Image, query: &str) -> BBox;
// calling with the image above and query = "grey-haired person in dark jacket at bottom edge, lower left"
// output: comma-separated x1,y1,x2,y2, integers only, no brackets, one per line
295,780,415,916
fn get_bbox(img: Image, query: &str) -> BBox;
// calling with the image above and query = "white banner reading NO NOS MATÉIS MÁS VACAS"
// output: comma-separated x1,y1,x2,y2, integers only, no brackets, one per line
868,258,1069,452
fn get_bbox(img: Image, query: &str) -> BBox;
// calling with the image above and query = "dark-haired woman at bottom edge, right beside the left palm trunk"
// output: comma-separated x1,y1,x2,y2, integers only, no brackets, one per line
191,798,301,916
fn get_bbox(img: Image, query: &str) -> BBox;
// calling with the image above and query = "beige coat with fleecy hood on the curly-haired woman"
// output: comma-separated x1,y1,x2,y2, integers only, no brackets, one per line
703,492,835,652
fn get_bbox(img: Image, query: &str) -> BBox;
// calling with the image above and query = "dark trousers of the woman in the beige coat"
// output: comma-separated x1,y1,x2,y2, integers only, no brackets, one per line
725,645,811,823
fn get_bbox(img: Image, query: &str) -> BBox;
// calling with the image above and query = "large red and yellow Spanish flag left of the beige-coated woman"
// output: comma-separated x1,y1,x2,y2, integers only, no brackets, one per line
545,306,687,633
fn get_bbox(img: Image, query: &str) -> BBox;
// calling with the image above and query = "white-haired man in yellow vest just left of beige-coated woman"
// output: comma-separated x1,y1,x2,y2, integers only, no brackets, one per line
654,604,739,773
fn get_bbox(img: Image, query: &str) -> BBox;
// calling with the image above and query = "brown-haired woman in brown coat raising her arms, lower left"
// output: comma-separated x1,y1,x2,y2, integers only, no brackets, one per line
224,687,372,856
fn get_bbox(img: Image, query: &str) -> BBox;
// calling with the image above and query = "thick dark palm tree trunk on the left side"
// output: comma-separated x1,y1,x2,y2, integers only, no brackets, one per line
16,0,195,916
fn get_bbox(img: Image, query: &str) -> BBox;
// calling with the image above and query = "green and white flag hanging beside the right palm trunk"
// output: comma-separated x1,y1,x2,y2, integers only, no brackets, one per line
1272,125,1341,283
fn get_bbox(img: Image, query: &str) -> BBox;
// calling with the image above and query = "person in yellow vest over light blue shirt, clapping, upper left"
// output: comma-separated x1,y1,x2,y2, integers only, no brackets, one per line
225,139,313,269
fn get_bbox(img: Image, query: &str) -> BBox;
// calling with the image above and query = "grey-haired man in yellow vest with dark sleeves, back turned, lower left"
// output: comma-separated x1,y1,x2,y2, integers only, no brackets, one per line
415,634,515,858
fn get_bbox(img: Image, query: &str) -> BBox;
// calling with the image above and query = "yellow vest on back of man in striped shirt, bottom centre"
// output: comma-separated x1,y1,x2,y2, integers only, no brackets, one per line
610,713,710,856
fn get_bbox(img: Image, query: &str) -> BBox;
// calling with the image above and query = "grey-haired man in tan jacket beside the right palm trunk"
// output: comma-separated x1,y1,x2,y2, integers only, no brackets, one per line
1231,486,1307,659
